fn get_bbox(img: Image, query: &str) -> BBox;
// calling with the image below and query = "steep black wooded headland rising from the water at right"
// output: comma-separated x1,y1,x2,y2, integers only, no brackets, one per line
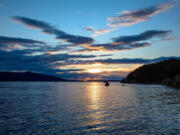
121,59,180,88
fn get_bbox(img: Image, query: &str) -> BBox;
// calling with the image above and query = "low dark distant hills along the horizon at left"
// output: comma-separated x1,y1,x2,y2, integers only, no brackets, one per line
0,72,66,81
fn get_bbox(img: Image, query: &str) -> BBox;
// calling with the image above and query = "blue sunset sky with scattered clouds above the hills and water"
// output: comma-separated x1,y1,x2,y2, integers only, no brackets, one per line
0,0,180,80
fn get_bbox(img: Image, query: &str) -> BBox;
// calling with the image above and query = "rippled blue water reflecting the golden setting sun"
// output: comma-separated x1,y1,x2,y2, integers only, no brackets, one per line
0,82,180,135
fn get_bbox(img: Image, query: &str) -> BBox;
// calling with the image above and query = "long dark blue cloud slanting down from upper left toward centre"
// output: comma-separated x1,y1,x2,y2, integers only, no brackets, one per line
12,16,94,44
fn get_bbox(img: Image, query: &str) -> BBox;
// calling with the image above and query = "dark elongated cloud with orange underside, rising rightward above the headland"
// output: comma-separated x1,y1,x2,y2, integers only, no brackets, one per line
74,30,172,52
